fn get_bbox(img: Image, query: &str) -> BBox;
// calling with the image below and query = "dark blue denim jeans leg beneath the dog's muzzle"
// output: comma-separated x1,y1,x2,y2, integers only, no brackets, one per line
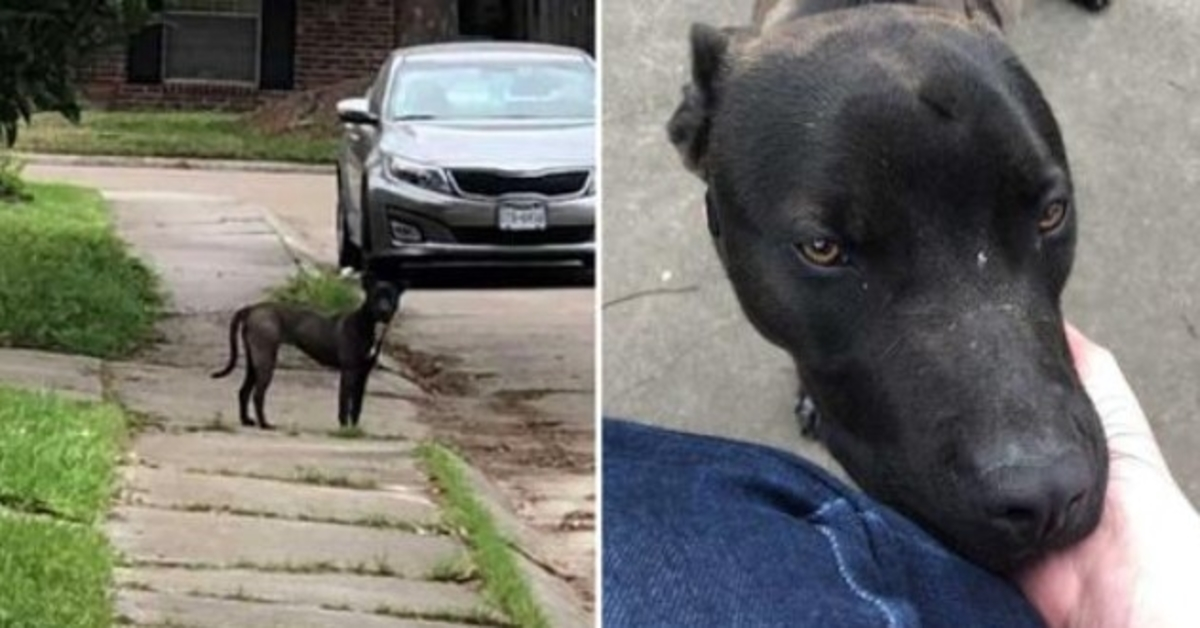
602,419,1043,628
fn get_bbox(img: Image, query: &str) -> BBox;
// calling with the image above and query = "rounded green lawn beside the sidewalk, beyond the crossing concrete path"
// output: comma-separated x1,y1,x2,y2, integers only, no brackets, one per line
0,184,162,358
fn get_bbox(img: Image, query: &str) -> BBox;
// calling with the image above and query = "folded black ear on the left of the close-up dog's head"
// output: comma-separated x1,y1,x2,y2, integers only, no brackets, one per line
667,23,744,179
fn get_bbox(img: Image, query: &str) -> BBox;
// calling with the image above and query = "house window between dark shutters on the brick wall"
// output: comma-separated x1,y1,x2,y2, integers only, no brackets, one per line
162,0,263,84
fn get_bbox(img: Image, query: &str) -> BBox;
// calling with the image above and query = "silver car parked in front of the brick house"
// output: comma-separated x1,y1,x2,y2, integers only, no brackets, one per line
337,43,595,276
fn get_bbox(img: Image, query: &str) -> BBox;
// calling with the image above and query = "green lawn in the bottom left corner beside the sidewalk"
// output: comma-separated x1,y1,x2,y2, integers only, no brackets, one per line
0,388,125,628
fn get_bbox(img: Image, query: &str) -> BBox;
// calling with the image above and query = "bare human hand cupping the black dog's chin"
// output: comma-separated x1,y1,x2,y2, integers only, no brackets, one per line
1016,323,1200,628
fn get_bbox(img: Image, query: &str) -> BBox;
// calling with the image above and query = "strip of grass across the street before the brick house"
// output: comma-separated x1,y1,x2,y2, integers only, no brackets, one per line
14,110,337,163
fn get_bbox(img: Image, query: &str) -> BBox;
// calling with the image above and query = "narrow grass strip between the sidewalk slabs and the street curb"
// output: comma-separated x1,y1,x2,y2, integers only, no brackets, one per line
418,443,550,628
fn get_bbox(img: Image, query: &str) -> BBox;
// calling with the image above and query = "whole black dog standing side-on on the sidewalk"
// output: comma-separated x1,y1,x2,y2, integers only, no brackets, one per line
212,283,400,430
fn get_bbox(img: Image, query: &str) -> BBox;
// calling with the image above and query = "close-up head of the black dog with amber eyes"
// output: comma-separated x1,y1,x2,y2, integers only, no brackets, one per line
670,6,1108,572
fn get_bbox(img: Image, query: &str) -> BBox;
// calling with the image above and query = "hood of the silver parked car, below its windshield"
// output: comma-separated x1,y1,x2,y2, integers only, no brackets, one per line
379,120,595,171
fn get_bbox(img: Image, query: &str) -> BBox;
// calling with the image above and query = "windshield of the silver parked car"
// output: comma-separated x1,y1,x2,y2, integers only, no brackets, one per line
388,55,595,120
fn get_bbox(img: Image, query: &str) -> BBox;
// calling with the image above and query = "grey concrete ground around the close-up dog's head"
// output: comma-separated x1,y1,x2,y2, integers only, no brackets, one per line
602,0,1200,503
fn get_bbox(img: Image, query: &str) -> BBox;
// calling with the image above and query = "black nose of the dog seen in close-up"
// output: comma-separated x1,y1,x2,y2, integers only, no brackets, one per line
983,455,1092,544
